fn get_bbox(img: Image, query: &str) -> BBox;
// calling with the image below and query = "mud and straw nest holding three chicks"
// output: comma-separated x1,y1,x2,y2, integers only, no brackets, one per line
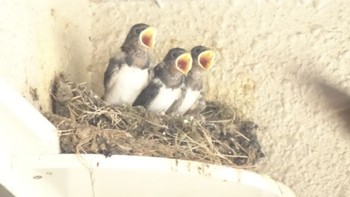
45,75,264,167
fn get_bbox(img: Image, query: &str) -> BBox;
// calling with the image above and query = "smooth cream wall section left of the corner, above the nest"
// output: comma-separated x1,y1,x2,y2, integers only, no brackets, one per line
0,0,91,111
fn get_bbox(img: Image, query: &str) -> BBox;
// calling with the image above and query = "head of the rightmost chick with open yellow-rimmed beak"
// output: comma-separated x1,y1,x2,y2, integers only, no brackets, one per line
191,46,215,71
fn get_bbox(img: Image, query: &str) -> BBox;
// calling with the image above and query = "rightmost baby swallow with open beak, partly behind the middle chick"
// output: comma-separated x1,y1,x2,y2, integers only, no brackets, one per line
167,46,214,115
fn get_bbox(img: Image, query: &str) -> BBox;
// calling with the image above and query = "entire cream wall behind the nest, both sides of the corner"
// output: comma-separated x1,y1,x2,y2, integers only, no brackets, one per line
0,0,350,197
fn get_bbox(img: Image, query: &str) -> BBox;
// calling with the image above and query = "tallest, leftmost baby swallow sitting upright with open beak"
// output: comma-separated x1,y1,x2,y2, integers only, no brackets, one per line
103,23,155,105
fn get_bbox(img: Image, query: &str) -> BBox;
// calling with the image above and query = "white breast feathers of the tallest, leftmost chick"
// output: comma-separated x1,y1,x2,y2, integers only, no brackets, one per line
104,64,148,105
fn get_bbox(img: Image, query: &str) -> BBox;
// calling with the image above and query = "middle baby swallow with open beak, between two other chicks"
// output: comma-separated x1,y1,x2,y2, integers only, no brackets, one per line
133,48,192,114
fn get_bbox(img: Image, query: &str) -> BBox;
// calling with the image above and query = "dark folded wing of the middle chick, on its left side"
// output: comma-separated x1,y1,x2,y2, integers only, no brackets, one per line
133,79,162,108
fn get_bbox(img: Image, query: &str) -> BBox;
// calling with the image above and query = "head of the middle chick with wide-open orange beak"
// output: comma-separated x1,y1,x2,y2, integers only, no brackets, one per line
164,48,192,75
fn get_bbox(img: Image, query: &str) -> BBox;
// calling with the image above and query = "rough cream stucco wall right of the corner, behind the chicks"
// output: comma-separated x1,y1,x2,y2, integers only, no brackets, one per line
92,0,350,197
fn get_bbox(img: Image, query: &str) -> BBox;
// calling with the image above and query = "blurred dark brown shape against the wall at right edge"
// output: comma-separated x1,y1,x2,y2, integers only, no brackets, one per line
317,82,350,139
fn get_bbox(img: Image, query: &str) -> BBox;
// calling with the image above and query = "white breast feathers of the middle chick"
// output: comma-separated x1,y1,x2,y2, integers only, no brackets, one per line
148,80,181,113
